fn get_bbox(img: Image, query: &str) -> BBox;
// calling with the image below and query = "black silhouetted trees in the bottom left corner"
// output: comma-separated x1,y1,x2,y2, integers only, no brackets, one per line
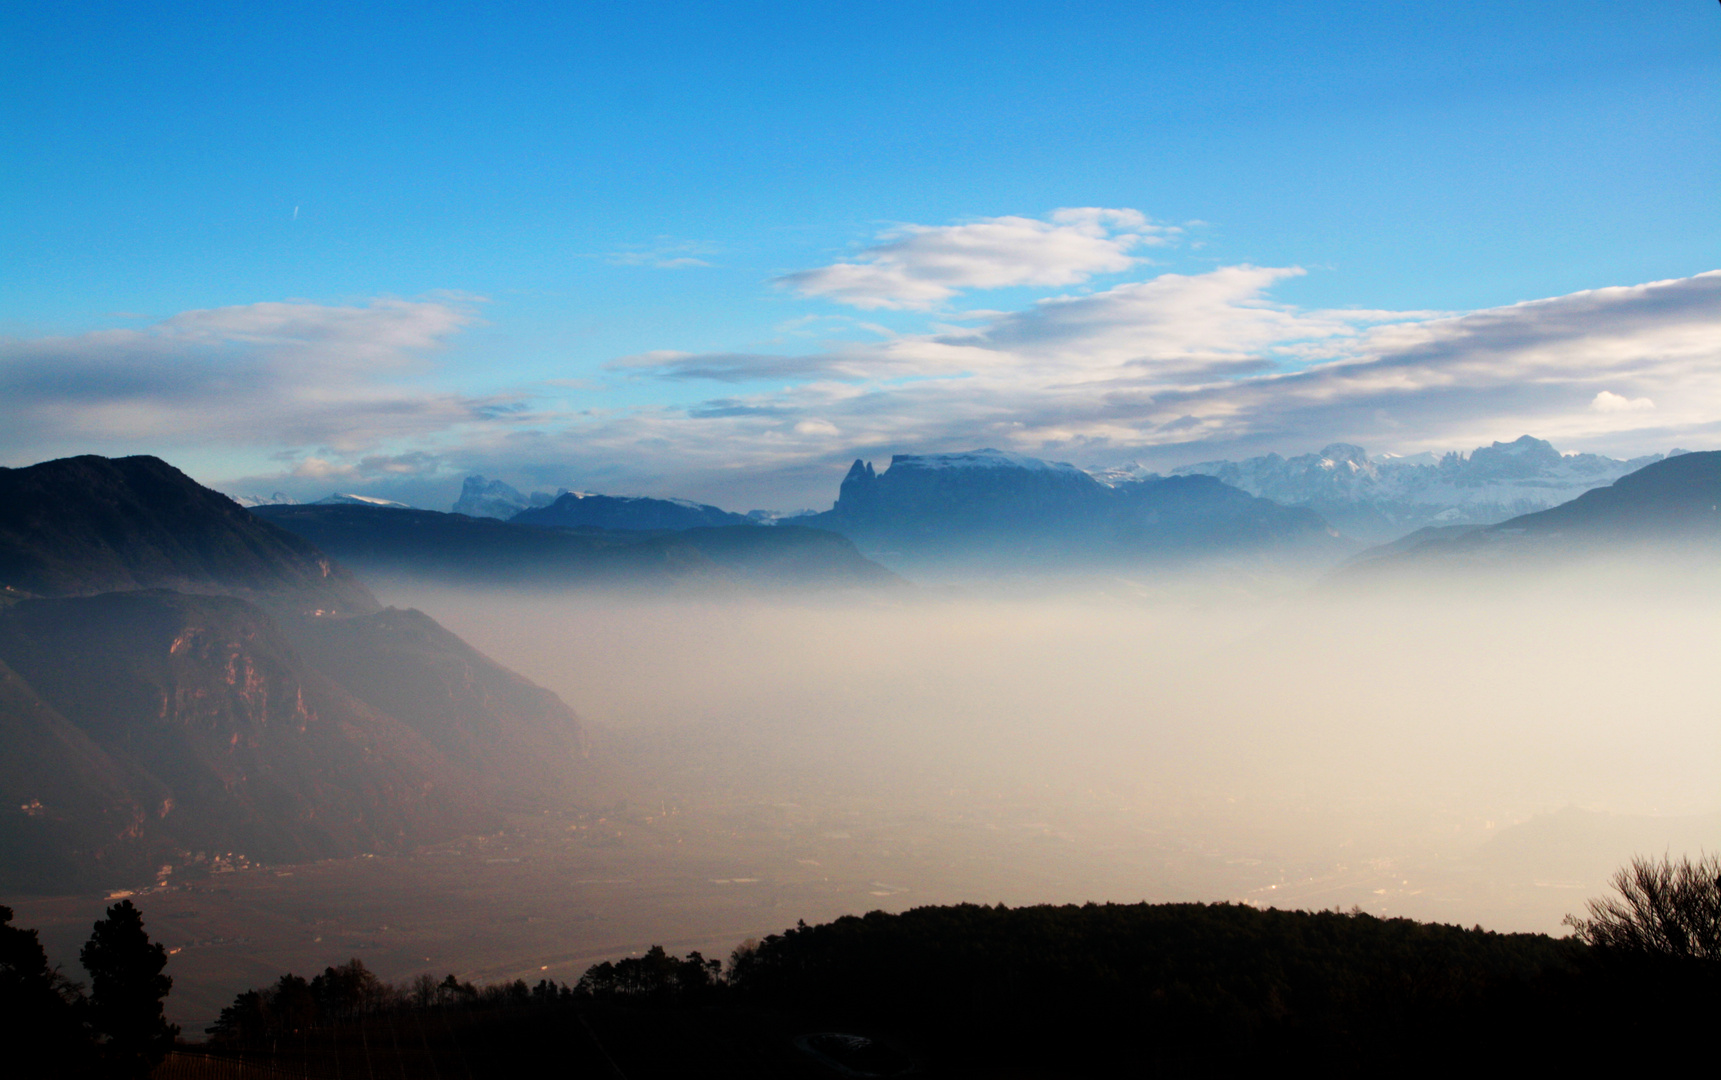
0,899,179,1080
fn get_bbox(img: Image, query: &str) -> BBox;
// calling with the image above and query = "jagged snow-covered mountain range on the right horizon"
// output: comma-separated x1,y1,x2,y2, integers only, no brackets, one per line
1095,435,1659,542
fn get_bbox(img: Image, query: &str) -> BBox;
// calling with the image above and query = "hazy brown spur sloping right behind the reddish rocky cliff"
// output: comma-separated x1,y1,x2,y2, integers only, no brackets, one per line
275,607,587,803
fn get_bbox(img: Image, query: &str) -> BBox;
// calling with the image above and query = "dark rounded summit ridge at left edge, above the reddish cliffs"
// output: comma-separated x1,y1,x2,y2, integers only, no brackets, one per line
0,456,377,611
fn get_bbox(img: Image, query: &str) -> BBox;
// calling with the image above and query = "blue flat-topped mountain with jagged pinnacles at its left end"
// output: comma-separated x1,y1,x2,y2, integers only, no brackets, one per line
805,451,1335,568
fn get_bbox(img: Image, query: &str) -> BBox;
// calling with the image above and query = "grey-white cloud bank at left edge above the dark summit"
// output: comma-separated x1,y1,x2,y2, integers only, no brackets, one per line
0,299,516,454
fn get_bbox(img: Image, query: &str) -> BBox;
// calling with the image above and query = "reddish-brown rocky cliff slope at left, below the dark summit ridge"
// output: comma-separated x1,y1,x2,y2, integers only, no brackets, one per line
0,590,492,881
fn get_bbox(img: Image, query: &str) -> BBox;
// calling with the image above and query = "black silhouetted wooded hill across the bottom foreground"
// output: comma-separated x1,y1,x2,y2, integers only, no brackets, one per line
162,903,1721,1080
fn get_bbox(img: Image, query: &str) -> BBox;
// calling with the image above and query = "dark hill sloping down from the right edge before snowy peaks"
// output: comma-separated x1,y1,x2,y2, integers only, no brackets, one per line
1335,451,1721,585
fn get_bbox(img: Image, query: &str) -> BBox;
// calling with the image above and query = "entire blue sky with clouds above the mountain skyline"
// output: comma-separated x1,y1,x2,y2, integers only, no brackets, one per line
0,0,1721,507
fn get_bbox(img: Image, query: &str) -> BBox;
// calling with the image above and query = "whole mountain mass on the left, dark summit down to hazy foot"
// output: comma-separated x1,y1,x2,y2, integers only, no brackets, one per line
0,457,585,891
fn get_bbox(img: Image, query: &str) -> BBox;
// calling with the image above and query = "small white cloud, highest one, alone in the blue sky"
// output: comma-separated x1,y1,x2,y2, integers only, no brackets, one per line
776,206,1179,310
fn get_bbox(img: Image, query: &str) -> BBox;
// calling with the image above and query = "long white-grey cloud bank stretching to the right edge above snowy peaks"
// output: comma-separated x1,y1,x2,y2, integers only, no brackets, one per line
578,267,1721,500
